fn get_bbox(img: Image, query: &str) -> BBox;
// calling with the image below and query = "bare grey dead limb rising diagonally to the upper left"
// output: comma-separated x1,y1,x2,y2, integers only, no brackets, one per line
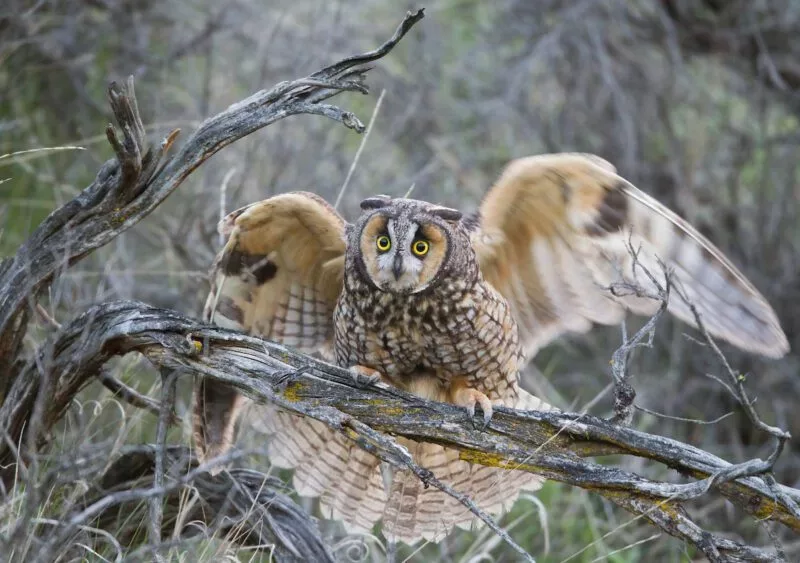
0,10,423,388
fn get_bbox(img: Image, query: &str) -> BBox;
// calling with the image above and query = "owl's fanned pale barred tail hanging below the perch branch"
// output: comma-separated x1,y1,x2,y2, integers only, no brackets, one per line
262,390,552,545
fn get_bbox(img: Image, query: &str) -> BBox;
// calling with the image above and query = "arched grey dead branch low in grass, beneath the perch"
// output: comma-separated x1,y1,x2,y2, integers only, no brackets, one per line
37,445,334,562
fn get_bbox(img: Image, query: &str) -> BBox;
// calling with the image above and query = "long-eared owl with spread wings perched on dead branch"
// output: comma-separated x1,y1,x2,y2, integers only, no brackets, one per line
194,154,789,543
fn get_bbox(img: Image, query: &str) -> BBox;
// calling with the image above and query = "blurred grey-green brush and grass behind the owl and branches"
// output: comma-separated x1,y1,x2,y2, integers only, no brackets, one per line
0,0,800,562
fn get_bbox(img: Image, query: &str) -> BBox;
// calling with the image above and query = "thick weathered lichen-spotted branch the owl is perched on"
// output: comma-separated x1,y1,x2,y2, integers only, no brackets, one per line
0,301,800,561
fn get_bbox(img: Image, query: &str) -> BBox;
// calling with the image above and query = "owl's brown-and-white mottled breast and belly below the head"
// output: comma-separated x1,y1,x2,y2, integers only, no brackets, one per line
334,280,521,399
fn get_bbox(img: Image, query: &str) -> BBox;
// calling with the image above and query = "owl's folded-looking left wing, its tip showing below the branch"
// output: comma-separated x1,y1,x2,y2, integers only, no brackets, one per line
194,192,345,460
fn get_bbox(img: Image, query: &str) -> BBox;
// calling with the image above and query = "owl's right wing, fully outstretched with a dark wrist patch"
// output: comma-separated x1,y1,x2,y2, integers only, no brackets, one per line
468,154,789,364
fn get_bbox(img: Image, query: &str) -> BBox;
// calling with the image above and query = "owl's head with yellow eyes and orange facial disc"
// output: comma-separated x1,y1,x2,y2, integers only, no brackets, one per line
347,196,474,295
